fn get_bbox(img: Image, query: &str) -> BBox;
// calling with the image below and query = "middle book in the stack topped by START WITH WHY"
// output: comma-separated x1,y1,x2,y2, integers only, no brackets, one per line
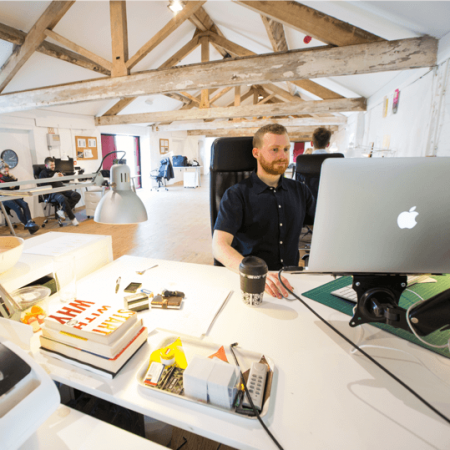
42,319,143,358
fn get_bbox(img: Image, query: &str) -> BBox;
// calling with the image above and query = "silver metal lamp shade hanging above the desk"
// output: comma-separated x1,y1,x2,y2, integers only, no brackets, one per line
94,164,148,225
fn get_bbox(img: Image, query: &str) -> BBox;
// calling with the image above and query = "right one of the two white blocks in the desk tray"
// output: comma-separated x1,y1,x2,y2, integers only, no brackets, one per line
208,360,239,409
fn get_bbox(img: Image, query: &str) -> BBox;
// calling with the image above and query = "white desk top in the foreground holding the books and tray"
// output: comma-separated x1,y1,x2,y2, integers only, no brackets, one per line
34,256,450,450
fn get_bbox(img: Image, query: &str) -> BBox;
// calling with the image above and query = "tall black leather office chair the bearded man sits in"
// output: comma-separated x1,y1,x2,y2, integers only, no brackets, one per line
209,137,256,266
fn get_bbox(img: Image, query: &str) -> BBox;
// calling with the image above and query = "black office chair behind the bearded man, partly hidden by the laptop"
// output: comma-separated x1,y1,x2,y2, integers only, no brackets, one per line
295,153,344,264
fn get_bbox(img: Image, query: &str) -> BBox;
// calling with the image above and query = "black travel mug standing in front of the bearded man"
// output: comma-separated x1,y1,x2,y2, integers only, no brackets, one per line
239,256,269,306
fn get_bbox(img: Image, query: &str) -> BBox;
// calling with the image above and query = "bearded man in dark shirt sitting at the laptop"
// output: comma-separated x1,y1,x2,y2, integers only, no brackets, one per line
213,124,315,298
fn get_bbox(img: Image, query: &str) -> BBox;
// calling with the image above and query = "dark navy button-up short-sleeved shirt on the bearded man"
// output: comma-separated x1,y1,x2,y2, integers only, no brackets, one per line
214,172,315,270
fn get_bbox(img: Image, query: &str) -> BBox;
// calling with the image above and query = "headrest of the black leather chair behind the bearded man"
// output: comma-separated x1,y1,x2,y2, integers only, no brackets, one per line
210,137,256,172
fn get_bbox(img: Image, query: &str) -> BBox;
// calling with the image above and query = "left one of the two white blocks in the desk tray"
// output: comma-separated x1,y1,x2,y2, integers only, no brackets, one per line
183,356,214,403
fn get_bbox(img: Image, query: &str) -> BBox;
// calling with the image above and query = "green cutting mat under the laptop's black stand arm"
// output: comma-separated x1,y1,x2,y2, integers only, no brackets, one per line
302,275,450,358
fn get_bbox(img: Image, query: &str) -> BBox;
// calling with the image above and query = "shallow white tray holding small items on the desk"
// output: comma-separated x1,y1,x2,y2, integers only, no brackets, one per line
137,332,275,419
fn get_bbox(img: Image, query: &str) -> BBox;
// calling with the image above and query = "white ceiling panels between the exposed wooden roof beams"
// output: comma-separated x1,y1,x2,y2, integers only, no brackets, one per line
0,0,450,123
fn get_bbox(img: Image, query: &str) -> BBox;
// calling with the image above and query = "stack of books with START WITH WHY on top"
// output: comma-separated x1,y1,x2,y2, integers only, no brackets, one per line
39,300,148,378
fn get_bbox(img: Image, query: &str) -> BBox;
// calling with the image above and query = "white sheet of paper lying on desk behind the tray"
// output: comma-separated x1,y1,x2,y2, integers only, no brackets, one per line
143,287,232,337
